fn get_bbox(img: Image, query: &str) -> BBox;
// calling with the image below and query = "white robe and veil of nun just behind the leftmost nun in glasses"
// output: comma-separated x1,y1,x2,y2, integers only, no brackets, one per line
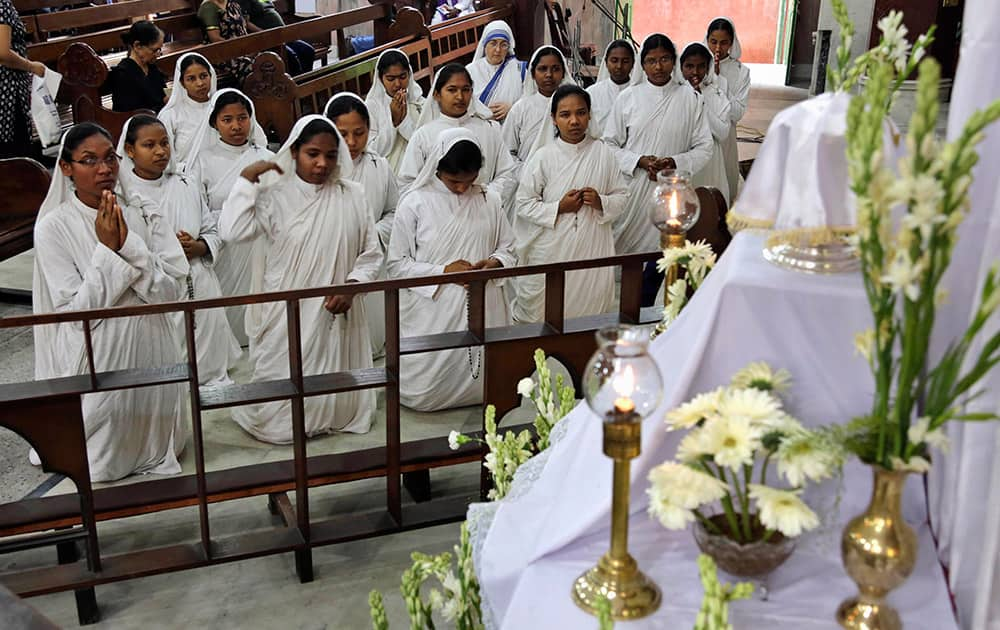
118,117,242,386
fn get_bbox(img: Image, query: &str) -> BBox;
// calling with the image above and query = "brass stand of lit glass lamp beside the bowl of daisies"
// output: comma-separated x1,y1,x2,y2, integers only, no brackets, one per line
573,399,661,620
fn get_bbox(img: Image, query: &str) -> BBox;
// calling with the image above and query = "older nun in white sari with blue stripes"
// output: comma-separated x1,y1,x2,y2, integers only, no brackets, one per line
466,20,528,122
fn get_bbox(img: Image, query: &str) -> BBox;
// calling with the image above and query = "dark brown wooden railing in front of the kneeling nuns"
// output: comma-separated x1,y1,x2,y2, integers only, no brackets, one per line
0,249,672,623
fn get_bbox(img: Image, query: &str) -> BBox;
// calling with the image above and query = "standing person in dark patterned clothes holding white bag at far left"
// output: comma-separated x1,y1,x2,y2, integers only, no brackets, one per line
0,0,45,158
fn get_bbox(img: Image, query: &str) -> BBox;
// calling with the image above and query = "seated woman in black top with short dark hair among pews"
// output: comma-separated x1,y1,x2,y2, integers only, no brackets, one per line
108,20,167,112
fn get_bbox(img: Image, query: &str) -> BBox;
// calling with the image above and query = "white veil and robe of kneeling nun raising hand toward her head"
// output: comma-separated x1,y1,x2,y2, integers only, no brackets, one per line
219,115,382,444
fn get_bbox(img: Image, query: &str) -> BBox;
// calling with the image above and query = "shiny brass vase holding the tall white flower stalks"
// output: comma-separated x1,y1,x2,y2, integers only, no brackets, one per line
837,466,917,630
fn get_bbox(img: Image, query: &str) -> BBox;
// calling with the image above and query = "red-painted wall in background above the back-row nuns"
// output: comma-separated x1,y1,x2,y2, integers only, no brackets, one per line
632,0,780,63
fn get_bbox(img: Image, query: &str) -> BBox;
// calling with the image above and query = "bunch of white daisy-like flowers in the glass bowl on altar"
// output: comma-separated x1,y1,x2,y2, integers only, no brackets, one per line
647,362,843,544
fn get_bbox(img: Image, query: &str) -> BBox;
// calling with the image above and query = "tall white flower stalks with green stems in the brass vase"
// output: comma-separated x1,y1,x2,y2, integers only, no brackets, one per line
837,2,1000,472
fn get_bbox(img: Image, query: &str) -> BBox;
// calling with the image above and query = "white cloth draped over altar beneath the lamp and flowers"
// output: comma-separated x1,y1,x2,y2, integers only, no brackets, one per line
469,232,955,630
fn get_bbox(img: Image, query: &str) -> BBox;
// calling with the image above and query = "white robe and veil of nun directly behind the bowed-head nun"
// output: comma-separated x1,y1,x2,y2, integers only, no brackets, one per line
399,70,517,200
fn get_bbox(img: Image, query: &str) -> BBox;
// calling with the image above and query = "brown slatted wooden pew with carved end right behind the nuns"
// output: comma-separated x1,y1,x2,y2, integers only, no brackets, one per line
243,5,512,142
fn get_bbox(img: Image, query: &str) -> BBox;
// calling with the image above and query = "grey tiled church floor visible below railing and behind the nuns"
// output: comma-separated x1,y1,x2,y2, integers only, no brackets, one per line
0,66,805,630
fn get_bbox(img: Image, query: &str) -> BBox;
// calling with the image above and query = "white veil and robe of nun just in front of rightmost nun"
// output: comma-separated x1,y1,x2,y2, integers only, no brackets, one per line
674,42,730,204
